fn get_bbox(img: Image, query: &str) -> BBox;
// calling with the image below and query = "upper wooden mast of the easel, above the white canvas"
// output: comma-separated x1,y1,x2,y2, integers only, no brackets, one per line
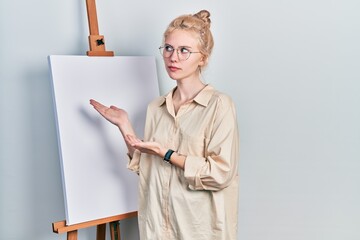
86,0,114,56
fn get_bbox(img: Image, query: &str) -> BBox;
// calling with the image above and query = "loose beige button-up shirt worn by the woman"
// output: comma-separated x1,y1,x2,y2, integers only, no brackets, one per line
128,85,239,240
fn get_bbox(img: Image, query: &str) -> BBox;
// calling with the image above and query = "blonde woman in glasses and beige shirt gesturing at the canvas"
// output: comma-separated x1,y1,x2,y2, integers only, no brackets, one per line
90,10,239,240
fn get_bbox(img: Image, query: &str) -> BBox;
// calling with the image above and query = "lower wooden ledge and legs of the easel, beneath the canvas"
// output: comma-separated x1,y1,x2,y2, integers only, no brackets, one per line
52,212,137,240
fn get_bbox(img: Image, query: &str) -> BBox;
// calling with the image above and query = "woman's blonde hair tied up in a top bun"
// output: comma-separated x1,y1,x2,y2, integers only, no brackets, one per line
164,10,214,65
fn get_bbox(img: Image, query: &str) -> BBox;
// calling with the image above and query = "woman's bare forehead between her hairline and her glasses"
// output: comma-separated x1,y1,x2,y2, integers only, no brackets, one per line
165,29,199,48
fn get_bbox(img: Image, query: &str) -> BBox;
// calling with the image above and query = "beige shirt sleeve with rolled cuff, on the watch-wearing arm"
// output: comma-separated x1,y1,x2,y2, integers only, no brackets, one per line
184,96,239,191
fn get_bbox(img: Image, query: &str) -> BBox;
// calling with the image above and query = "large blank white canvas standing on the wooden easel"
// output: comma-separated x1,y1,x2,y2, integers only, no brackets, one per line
49,56,159,225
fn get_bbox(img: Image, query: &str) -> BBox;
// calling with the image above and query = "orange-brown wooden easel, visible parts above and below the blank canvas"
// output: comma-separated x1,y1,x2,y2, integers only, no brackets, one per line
52,0,137,240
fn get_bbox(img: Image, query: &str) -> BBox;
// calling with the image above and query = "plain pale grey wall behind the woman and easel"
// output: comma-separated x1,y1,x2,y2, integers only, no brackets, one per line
0,0,360,240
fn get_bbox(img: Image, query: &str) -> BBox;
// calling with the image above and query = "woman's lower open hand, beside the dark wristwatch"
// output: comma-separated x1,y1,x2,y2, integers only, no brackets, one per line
125,135,166,157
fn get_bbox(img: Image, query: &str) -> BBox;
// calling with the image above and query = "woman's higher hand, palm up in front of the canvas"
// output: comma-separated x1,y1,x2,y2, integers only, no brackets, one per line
90,99,129,128
